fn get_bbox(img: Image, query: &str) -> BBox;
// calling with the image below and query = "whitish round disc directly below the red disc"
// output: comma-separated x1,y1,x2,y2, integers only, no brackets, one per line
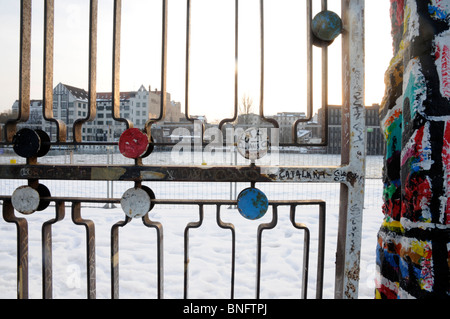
120,187,151,218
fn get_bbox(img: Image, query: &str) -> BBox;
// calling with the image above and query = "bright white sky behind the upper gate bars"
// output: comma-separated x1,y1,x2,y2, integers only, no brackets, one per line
0,0,392,120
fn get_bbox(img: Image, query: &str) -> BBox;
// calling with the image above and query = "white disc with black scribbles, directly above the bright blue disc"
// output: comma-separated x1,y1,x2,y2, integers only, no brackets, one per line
237,127,269,160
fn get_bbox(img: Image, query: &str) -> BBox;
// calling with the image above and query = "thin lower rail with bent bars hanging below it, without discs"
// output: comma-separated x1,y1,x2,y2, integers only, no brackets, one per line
0,196,326,299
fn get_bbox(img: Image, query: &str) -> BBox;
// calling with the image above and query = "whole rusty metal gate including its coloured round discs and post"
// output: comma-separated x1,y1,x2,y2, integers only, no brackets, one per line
0,0,365,298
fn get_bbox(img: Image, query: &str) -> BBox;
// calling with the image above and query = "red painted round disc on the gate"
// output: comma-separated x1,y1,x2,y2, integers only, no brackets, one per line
119,128,149,159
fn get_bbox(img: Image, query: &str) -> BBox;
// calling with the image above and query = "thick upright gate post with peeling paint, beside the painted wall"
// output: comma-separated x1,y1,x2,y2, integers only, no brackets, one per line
335,0,365,298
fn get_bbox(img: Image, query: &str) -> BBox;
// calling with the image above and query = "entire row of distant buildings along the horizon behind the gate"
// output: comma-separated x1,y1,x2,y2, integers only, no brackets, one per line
5,83,384,155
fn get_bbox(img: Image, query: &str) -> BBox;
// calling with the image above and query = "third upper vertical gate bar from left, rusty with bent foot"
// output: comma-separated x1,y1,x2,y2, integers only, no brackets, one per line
73,0,98,143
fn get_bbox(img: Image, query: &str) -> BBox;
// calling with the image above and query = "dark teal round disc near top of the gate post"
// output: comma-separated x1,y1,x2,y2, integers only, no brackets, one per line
311,11,342,41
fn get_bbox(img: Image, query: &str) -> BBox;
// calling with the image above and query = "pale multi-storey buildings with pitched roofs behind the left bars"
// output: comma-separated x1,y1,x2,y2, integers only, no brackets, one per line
12,83,184,142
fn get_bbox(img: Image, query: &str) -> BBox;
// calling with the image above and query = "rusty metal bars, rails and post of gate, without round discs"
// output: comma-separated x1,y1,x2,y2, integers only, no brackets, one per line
0,0,365,298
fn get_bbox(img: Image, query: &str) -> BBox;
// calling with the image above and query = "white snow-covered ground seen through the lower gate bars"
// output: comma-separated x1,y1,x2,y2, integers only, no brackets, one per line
0,154,382,298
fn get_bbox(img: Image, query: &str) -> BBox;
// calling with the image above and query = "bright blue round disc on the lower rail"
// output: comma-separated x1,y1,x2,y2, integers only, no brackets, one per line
237,187,269,220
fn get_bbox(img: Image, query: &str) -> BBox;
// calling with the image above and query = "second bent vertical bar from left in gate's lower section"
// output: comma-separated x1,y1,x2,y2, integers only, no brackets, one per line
42,202,65,299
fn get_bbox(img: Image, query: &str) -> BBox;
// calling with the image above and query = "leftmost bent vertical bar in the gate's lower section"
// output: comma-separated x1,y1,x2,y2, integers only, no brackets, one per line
3,200,28,299
